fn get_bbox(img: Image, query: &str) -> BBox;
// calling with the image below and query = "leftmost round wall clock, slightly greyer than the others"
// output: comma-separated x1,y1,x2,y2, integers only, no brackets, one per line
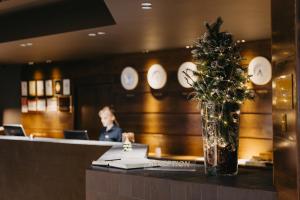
121,67,139,90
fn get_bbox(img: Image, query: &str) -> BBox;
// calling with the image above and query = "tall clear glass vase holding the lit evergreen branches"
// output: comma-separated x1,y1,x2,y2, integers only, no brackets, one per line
201,102,240,176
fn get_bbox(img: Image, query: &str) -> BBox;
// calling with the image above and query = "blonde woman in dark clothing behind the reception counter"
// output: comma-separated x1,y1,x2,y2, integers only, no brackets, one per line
99,106,122,142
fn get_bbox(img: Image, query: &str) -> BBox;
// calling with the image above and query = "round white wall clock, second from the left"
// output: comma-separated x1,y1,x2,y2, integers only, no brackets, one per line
147,64,167,89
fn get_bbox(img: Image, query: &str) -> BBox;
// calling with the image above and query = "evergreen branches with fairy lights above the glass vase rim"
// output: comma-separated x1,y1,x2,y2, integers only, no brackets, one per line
183,17,254,104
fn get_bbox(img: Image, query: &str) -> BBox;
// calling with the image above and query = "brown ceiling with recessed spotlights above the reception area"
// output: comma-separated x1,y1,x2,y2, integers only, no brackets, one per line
0,0,271,64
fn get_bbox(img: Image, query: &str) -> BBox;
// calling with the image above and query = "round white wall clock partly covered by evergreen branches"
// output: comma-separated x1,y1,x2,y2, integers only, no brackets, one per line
177,62,197,88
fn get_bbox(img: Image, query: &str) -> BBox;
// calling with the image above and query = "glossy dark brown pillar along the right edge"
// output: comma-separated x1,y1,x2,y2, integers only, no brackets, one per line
271,0,300,200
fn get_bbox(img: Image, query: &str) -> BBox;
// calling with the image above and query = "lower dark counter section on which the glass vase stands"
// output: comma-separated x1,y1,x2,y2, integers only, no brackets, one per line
86,167,277,200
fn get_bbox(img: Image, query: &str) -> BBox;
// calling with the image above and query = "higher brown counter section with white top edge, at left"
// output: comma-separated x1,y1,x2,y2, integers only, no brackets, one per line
0,136,116,200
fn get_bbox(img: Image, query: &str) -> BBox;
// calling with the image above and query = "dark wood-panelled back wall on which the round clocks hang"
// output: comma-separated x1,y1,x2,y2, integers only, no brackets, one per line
24,40,272,157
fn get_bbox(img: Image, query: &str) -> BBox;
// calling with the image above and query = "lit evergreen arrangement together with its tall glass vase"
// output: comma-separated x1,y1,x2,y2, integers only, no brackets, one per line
183,18,254,175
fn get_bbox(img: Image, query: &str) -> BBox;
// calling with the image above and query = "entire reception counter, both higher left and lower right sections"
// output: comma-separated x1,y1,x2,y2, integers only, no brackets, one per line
0,136,276,200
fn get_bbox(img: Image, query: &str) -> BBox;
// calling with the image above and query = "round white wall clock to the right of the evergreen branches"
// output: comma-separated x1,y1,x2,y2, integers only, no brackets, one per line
248,56,272,85
